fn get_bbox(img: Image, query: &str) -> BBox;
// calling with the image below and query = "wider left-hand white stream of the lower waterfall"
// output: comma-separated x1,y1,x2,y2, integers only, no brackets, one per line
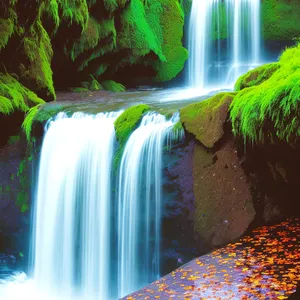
33,113,116,300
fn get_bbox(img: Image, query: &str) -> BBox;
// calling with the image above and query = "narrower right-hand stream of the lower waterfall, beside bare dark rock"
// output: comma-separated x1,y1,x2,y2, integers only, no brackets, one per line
118,113,179,297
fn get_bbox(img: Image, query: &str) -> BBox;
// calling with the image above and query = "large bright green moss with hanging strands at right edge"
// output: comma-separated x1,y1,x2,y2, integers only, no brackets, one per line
230,43,300,143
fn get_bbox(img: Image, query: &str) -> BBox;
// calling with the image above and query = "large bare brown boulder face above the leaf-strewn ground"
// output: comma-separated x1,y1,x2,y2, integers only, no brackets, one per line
193,139,255,248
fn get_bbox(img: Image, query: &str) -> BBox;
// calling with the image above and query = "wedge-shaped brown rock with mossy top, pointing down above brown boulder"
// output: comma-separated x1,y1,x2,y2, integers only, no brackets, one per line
180,93,235,148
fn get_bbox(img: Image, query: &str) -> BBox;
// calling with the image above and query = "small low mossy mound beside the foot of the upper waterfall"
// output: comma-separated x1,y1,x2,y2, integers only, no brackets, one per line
235,63,280,91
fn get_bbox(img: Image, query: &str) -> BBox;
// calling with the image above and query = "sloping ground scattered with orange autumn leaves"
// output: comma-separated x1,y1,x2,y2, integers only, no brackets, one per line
124,219,300,300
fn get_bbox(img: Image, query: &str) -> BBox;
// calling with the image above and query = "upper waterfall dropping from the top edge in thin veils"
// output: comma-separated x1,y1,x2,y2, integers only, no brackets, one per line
188,0,261,90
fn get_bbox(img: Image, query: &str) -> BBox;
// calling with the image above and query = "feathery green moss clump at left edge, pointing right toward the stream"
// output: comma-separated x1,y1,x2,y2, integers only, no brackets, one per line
0,73,45,115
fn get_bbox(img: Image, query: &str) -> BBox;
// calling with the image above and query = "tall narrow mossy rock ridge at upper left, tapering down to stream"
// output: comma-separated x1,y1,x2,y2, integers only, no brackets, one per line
22,20,56,99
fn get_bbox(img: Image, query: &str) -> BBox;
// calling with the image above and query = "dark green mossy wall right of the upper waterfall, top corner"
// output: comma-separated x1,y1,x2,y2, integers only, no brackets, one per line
262,0,300,41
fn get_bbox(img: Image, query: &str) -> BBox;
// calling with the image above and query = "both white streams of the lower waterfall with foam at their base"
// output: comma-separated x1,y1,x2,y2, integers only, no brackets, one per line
0,113,183,300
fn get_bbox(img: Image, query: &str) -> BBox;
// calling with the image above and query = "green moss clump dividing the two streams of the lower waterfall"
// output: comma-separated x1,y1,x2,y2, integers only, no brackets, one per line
114,104,150,169
